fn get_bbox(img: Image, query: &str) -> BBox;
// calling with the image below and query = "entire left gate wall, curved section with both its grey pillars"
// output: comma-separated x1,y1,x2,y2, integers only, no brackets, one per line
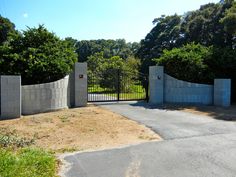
0,63,87,118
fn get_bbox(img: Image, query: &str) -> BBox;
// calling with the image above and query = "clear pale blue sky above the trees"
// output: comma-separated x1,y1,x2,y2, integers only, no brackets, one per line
0,0,219,42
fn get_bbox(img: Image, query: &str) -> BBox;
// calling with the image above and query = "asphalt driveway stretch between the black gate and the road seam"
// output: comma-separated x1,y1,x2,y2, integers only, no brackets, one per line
98,102,236,139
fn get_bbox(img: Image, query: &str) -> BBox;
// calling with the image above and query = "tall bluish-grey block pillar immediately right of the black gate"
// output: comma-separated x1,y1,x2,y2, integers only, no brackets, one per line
149,66,164,104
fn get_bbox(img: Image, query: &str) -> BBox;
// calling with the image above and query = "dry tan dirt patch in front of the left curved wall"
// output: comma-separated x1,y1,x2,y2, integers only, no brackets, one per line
0,105,161,152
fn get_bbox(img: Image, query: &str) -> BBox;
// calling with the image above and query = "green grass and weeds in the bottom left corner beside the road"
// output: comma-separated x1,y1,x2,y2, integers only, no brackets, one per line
0,129,57,177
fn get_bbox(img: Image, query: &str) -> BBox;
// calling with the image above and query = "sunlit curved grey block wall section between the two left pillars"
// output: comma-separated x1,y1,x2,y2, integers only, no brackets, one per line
22,76,70,114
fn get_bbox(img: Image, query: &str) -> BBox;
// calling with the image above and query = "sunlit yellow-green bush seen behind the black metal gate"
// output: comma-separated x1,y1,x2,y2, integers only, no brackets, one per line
87,52,140,92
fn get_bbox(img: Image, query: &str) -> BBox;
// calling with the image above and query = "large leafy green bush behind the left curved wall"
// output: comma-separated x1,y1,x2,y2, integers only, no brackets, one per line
0,20,77,84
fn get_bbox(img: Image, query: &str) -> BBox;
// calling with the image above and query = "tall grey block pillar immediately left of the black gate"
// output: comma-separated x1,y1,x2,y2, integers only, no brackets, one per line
74,63,88,107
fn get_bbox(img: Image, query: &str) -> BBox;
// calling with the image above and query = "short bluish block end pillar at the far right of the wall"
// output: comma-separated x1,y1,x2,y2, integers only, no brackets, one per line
214,79,231,107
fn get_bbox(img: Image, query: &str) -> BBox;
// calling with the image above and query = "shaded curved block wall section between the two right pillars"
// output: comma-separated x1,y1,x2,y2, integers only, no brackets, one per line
164,74,213,105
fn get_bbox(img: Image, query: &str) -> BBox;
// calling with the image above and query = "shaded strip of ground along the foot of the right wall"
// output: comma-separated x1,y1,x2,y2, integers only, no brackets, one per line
130,102,236,121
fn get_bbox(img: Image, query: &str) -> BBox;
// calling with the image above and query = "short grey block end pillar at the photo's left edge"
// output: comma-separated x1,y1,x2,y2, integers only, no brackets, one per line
1,76,21,119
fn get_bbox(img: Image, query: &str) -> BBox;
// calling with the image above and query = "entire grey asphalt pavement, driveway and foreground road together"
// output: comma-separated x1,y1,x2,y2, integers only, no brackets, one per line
60,103,236,177
